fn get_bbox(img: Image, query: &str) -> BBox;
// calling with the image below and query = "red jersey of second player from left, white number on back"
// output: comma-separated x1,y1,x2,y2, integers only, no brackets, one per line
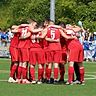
18,27,30,48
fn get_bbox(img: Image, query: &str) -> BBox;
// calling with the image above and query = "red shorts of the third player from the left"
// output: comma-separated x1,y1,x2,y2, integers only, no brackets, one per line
29,48,45,65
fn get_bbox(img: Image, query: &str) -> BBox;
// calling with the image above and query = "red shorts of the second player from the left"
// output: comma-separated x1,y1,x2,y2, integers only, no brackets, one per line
19,48,29,62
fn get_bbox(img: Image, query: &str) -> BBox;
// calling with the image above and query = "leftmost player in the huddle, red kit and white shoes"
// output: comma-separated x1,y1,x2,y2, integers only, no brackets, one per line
8,25,19,83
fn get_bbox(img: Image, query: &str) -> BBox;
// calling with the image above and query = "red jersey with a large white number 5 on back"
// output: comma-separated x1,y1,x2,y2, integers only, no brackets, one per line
47,26,61,50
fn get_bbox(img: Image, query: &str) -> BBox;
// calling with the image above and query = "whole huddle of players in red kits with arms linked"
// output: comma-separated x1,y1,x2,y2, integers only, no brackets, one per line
8,20,84,85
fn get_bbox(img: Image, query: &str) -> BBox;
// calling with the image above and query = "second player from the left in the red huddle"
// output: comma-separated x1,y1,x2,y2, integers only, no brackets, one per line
17,25,31,83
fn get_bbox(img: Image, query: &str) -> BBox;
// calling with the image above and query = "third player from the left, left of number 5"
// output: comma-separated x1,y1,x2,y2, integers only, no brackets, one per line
29,22,45,84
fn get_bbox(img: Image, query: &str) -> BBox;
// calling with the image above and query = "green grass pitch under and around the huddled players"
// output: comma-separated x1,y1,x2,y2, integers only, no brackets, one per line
0,59,96,96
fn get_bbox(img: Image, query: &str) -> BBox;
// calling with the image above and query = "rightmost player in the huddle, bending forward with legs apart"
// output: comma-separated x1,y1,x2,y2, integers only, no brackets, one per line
66,25,84,85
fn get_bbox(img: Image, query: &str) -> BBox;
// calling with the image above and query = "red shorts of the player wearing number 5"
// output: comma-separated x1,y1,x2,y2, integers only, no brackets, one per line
48,50,62,63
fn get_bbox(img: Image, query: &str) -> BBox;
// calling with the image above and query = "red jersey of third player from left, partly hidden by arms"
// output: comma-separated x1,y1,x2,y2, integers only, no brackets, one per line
30,32,43,48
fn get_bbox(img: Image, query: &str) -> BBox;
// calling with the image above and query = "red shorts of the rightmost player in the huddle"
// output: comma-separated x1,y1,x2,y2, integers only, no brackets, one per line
68,46,84,62
